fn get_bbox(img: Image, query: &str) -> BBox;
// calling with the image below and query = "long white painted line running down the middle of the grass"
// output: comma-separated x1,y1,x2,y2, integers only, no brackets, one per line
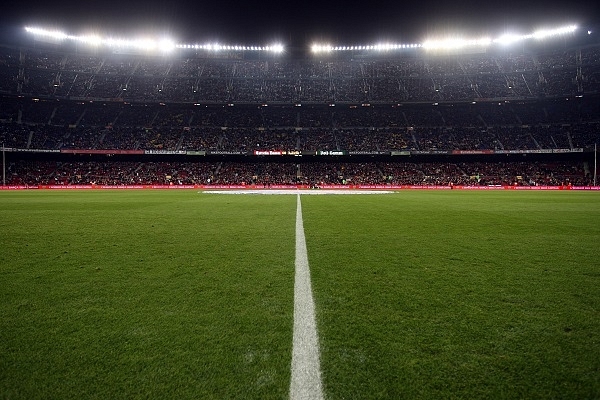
290,195,323,400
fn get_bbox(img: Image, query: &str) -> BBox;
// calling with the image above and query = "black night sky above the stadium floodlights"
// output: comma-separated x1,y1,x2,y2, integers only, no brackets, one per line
0,0,600,47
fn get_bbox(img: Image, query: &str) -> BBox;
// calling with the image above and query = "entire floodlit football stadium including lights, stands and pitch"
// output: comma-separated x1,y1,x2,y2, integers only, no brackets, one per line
0,21,600,400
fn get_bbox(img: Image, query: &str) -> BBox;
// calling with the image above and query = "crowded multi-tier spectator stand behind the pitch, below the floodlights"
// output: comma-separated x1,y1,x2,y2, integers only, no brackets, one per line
0,38,600,186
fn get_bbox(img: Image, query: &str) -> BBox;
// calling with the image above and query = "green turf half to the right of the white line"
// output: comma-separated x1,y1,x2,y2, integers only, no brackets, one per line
303,192,600,399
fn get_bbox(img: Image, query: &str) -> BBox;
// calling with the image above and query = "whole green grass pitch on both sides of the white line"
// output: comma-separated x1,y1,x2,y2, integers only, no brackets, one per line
0,190,600,399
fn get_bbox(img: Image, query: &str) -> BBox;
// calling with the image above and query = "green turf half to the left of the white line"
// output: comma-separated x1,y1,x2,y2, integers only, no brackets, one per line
0,192,295,399
